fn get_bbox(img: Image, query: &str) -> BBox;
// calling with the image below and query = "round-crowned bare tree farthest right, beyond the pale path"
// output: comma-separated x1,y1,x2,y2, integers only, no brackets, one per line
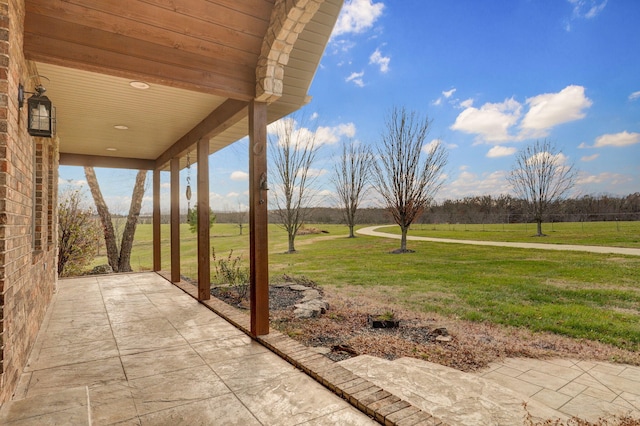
507,140,577,237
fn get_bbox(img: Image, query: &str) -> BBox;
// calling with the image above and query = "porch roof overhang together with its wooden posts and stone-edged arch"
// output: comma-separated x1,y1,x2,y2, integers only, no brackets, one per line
24,0,342,336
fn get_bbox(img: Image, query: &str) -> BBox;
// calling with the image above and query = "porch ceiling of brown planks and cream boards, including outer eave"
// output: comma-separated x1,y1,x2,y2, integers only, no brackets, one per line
24,0,342,170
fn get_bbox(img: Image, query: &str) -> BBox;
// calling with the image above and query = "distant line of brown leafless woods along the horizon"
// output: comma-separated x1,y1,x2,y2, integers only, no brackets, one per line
140,192,640,224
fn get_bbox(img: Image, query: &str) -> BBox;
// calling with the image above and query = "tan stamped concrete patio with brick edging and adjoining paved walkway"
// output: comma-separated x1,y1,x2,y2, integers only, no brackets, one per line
0,272,640,426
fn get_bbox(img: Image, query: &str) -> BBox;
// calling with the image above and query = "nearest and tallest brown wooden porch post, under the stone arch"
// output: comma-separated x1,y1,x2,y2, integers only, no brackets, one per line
249,100,269,336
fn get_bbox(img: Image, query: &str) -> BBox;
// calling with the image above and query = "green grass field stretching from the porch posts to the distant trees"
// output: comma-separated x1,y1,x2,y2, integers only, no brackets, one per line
90,223,640,351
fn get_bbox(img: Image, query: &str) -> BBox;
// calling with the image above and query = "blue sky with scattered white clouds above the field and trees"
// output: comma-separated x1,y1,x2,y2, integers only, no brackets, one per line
60,0,640,211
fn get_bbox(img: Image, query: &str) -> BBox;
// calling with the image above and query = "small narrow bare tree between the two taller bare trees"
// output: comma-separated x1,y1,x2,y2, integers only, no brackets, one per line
331,140,373,238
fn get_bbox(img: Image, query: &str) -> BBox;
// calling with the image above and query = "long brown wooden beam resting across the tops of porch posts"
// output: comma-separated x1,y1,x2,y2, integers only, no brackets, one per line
155,99,248,169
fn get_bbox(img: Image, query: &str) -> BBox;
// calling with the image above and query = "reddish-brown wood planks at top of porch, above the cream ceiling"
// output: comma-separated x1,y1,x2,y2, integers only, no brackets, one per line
25,0,272,100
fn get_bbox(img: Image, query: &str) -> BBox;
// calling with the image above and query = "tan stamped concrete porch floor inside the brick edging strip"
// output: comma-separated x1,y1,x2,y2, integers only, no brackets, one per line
0,273,375,425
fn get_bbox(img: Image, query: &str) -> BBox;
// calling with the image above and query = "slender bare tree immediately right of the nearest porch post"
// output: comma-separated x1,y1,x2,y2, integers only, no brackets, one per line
269,117,318,253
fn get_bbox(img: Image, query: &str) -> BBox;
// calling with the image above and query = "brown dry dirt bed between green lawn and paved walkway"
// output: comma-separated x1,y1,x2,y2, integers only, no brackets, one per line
271,289,640,371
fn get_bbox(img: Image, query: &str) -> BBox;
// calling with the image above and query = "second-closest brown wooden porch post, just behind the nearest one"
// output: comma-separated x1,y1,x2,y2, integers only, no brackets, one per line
197,138,211,300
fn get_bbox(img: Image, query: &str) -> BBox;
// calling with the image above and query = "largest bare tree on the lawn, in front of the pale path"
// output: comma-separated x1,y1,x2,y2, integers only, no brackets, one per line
373,108,447,253
